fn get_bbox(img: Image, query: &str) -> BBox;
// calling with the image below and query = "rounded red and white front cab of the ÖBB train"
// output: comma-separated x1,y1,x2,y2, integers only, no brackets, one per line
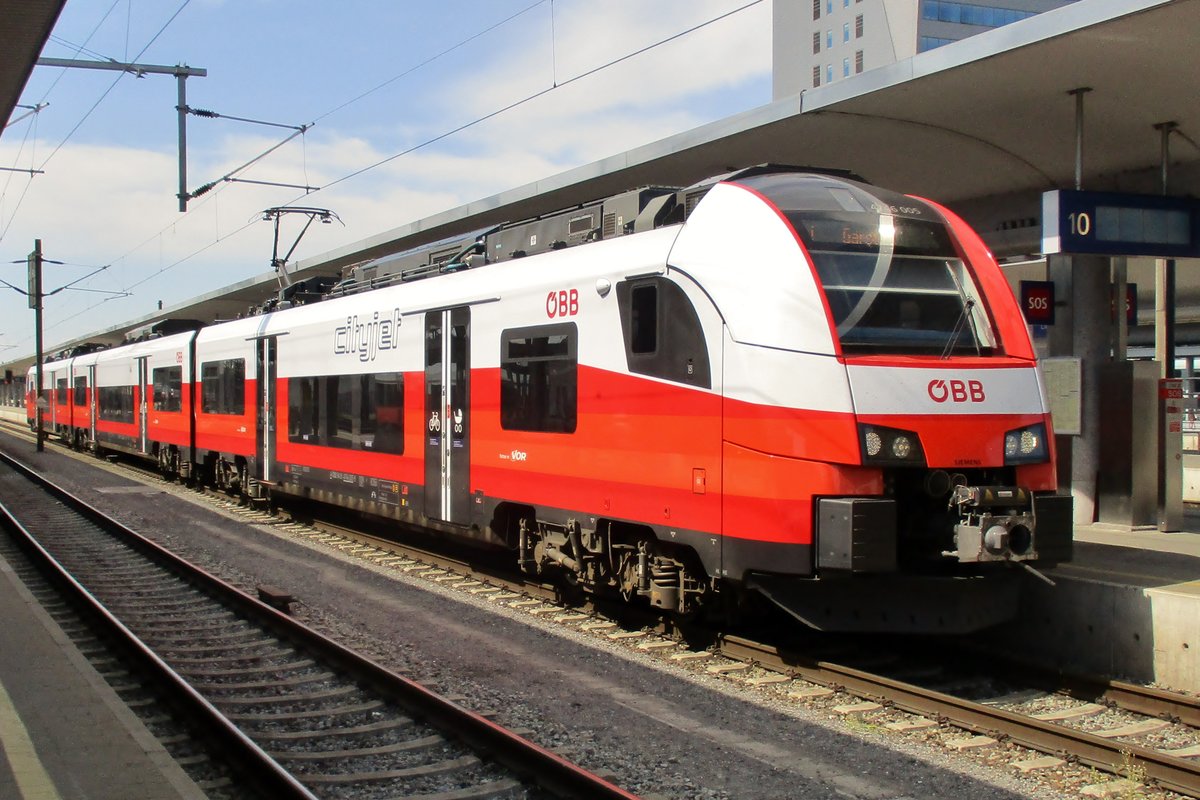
672,173,1072,633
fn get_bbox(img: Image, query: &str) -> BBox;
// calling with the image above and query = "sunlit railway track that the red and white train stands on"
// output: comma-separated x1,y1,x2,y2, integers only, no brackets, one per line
7,422,1200,798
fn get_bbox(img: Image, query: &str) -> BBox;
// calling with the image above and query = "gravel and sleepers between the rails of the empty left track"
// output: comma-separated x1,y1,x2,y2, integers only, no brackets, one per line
0,455,540,799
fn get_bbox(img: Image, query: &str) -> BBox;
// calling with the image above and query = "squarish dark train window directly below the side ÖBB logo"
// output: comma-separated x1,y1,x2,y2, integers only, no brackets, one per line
500,323,578,433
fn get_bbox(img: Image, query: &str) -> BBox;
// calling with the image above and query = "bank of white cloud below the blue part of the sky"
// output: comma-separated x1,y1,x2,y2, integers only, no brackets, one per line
0,0,770,355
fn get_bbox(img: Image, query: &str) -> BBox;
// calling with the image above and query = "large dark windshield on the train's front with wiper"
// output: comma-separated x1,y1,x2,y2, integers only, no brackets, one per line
787,208,996,356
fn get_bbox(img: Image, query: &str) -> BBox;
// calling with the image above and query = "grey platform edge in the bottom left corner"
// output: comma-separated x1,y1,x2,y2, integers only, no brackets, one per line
0,546,205,800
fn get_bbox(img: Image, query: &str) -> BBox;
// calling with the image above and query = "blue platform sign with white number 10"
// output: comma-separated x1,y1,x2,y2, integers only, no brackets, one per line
1042,190,1200,258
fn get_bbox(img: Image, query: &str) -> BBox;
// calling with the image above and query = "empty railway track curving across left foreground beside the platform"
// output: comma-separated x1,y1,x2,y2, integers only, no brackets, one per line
0,457,634,800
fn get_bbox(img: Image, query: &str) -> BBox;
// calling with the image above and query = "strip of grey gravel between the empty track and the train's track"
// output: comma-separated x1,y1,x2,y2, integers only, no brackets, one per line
4,434,1195,800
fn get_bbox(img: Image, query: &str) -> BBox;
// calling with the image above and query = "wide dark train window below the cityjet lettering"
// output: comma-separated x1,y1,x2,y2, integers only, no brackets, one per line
288,373,404,456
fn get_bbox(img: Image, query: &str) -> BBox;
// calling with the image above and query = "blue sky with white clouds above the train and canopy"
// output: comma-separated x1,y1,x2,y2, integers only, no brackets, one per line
0,0,772,362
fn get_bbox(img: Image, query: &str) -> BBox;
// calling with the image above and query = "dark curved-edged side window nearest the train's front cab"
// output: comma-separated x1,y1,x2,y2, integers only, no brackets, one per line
617,277,712,389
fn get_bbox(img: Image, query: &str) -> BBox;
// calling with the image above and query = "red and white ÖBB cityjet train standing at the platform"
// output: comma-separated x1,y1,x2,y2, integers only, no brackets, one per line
26,166,1073,633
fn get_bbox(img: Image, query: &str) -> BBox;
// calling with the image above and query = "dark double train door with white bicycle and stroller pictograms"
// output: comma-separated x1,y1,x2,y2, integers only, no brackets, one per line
425,307,470,525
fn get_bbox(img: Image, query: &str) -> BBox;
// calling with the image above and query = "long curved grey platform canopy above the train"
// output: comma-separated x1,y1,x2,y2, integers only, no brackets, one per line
0,0,1200,366
